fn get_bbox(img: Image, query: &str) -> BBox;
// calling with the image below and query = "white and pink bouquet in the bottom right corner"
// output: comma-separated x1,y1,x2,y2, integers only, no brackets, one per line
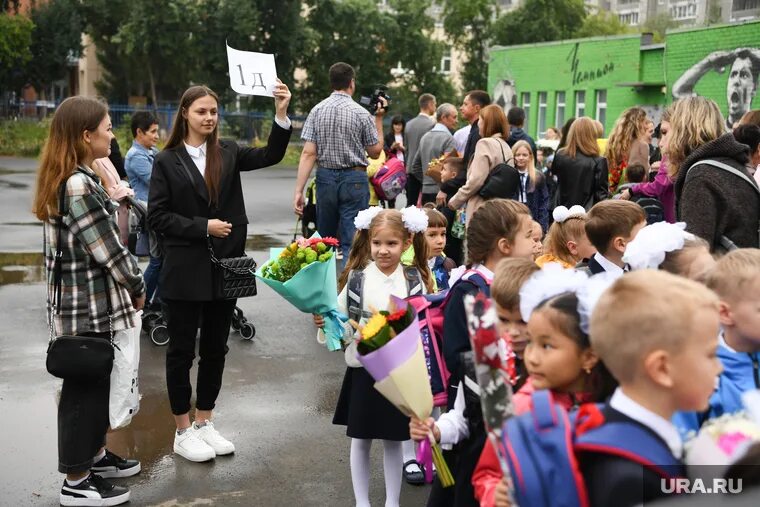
685,412,760,478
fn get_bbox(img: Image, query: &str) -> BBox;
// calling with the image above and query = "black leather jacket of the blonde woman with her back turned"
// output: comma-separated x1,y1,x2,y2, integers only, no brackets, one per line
552,150,609,210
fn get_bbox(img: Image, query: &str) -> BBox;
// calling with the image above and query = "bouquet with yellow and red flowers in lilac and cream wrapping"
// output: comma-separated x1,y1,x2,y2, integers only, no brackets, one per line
356,296,454,487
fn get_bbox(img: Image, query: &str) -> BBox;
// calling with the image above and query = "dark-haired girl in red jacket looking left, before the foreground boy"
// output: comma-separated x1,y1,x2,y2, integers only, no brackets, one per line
472,274,616,507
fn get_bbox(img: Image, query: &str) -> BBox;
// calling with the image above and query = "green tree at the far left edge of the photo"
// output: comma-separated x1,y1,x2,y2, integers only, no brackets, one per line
0,14,34,91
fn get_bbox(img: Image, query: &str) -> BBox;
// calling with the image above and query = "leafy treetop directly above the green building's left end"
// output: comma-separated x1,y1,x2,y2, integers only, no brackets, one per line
492,0,586,46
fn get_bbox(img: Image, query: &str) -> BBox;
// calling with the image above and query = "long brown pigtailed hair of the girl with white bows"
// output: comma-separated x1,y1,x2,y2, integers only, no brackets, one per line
338,209,433,293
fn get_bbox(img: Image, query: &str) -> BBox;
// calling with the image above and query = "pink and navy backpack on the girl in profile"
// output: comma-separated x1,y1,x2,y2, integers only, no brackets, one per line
406,270,488,407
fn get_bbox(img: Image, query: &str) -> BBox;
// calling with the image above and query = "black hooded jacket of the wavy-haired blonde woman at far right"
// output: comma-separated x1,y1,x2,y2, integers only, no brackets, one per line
674,133,760,250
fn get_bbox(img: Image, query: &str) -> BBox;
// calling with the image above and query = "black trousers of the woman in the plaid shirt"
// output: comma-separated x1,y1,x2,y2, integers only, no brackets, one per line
58,333,111,474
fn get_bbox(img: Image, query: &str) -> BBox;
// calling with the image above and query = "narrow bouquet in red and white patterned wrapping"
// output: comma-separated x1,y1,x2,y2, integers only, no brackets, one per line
464,293,517,505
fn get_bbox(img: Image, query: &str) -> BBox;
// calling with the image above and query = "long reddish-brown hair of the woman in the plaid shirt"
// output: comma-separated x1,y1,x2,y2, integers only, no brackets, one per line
32,96,108,220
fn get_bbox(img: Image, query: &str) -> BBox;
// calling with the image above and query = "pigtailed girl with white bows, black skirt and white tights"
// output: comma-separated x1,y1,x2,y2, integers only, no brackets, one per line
314,207,433,507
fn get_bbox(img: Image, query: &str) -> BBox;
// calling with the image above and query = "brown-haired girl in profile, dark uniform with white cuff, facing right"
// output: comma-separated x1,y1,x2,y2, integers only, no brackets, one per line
410,199,533,507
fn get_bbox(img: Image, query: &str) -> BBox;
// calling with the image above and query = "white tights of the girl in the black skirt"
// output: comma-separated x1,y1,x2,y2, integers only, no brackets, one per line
351,438,403,507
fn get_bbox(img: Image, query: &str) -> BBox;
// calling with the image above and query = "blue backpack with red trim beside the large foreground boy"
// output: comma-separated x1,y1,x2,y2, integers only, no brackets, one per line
501,390,683,507
